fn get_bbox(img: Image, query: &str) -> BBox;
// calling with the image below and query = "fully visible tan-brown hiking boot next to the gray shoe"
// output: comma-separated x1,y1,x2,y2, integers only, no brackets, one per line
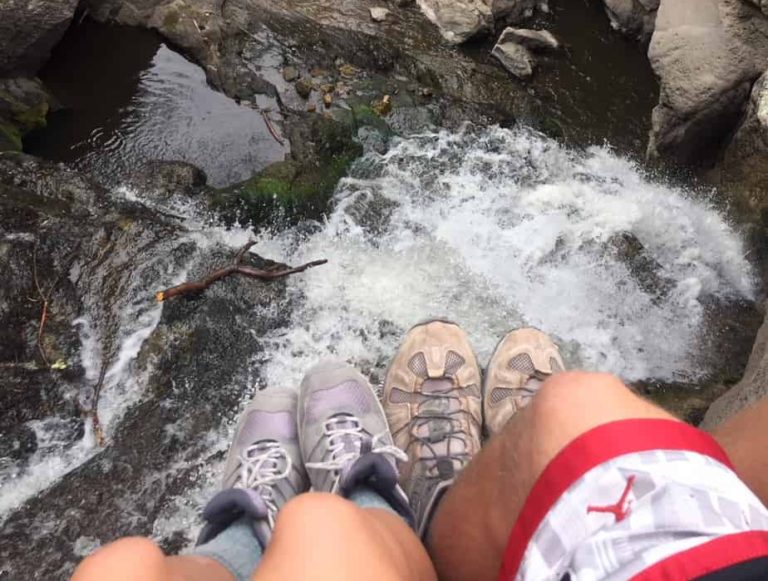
384,321,482,537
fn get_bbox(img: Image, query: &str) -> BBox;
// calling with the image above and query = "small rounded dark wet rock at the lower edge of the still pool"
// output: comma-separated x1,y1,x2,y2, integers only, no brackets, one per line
126,161,208,200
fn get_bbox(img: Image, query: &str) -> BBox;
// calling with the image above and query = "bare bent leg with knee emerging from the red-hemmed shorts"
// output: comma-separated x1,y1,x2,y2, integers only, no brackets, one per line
428,372,675,580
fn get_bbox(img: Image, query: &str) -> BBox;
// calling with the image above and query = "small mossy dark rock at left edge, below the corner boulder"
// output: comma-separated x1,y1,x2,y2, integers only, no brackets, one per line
0,78,51,152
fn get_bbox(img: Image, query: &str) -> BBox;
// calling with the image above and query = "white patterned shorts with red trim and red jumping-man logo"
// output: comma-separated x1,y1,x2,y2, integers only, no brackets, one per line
500,420,768,581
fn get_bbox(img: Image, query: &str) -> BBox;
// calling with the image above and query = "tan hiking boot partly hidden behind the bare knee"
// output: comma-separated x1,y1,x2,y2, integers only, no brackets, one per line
483,329,565,435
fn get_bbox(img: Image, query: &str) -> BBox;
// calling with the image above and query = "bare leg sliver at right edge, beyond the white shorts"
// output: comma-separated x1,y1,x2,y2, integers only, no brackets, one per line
712,398,768,505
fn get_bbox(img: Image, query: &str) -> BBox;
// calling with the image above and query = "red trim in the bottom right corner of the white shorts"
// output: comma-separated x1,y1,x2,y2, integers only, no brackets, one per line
632,531,768,581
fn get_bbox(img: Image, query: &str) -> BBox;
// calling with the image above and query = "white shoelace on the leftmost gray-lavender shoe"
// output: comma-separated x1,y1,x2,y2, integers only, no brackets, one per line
235,441,293,527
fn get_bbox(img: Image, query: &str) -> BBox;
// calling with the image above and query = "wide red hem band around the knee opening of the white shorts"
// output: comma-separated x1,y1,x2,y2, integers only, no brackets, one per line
499,419,733,581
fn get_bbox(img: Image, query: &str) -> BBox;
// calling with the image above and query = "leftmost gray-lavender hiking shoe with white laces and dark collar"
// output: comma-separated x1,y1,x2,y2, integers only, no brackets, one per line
197,390,309,547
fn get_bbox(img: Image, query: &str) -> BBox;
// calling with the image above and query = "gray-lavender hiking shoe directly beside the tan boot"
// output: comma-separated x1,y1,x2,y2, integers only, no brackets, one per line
298,361,413,522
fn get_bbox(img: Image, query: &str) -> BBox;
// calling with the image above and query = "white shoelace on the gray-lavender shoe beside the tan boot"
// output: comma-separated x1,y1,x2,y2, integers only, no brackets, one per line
304,415,408,492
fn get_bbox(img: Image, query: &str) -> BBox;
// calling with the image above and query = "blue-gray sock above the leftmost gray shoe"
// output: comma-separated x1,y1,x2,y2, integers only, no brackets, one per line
190,517,263,581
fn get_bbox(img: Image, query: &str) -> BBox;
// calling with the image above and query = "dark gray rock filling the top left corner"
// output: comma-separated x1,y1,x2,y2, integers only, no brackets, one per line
0,0,78,76
